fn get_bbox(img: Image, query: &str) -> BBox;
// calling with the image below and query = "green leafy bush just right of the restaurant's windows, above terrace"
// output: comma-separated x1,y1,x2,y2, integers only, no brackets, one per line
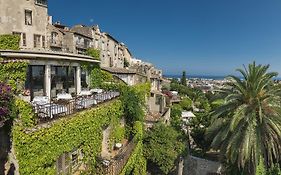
90,67,113,88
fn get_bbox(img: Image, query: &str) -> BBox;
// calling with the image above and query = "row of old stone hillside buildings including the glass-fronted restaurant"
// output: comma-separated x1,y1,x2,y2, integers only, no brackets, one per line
0,0,166,100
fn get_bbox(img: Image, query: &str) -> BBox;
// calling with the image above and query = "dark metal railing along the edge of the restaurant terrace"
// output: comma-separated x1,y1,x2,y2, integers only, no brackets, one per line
33,91,120,123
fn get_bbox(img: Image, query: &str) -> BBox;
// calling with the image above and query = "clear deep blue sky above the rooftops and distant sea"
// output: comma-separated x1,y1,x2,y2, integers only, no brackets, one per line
48,0,281,76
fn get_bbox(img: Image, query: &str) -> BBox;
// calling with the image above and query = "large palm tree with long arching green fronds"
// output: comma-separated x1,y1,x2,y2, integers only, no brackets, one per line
207,62,281,174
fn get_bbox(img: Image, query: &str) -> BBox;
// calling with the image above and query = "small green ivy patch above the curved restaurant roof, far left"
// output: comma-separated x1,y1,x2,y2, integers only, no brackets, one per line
0,35,20,50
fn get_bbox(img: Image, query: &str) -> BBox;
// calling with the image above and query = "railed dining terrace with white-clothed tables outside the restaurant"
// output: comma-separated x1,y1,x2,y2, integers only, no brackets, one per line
31,91,120,124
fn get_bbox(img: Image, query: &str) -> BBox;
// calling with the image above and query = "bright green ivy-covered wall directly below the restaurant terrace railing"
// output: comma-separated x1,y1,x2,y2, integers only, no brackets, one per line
13,100,123,175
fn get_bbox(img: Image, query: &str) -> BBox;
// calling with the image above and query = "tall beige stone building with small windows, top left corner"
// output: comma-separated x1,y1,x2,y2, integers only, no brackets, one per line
0,0,49,50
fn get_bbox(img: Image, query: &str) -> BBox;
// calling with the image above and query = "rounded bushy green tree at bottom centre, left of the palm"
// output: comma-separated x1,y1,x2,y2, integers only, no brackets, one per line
143,123,185,174
